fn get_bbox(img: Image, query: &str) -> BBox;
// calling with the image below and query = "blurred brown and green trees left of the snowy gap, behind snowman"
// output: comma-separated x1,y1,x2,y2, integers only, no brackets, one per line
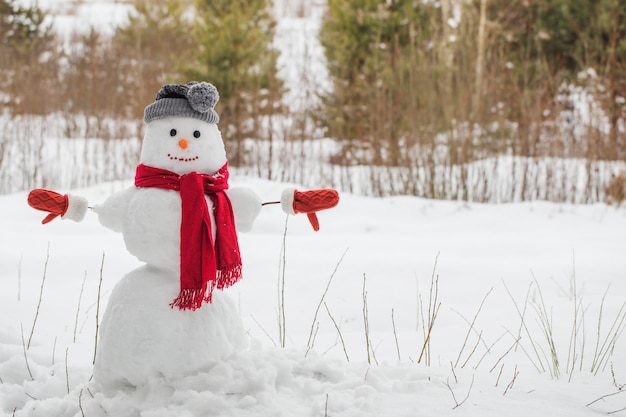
0,0,282,166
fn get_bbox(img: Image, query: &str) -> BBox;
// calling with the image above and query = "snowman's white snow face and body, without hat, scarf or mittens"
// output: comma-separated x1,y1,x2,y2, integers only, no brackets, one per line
94,112,261,389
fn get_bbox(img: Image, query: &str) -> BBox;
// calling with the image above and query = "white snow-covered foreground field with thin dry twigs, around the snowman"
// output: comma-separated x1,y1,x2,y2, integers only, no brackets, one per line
0,178,626,417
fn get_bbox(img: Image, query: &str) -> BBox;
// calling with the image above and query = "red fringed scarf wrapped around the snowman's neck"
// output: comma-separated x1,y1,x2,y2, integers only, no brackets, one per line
135,162,241,310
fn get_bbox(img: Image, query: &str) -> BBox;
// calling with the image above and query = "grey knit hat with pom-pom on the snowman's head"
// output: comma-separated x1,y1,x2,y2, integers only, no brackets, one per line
143,81,220,123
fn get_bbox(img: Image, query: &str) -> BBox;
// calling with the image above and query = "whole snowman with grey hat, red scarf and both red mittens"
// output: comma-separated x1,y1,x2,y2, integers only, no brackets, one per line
28,82,338,390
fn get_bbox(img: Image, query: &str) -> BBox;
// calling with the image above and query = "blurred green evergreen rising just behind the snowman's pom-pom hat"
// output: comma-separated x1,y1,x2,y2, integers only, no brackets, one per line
187,0,283,165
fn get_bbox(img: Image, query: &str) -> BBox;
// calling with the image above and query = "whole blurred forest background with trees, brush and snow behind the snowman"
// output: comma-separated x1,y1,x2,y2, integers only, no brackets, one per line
0,0,626,204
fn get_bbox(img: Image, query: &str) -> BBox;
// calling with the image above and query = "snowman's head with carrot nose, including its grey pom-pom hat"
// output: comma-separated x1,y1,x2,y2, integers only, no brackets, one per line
141,82,226,175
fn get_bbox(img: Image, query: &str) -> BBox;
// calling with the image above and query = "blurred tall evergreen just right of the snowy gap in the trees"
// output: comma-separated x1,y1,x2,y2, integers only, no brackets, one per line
320,0,437,164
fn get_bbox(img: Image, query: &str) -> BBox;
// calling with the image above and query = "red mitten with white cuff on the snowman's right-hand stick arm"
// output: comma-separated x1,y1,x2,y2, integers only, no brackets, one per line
281,188,339,232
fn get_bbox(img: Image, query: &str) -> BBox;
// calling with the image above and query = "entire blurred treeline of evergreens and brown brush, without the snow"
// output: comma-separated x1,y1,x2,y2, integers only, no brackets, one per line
0,0,626,202
